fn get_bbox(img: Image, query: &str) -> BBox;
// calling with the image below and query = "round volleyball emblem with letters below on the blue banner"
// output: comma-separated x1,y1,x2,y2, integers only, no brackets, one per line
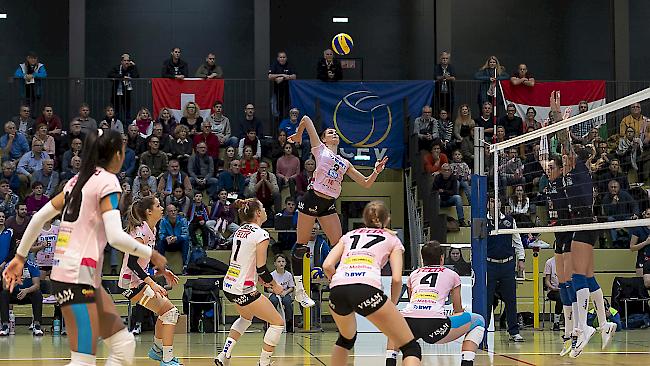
333,90,393,160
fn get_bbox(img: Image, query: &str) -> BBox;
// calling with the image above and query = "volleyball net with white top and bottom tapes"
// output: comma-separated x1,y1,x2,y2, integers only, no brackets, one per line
484,88,650,241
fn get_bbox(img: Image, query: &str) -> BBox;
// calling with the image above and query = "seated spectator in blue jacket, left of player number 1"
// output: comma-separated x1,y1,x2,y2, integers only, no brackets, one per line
156,205,190,274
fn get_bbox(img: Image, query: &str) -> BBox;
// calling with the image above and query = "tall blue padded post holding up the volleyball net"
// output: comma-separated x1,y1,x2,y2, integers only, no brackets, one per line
471,127,489,348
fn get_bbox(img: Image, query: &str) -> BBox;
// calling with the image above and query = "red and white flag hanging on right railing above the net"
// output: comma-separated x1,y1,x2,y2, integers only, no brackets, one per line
501,80,606,126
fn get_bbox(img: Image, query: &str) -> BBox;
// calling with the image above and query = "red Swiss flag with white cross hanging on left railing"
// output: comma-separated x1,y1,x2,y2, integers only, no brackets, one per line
151,79,223,121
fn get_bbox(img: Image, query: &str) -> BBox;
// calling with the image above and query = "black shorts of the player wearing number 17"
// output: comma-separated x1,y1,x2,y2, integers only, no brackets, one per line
330,284,388,317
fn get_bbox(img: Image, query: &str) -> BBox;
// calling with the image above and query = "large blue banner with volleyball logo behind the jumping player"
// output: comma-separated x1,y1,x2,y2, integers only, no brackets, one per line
290,80,433,169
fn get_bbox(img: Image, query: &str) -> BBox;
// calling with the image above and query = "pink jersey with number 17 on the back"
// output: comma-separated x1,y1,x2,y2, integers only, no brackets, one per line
330,228,404,290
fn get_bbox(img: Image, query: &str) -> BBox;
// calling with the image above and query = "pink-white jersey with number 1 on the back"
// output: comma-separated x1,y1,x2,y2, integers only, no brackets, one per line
223,223,269,295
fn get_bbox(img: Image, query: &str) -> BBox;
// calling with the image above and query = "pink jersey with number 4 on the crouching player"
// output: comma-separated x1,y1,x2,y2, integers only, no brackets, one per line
402,266,460,318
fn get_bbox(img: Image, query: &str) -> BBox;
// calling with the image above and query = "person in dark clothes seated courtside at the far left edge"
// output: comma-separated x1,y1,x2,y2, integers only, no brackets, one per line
0,258,43,337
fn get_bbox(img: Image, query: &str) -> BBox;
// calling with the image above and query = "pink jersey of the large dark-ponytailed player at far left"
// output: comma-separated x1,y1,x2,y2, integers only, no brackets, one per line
51,168,122,288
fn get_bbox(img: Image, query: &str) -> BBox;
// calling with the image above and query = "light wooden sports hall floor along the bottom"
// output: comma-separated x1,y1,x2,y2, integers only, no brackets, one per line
0,324,650,366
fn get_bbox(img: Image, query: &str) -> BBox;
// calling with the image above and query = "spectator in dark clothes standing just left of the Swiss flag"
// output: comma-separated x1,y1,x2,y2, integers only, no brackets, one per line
108,53,140,121
